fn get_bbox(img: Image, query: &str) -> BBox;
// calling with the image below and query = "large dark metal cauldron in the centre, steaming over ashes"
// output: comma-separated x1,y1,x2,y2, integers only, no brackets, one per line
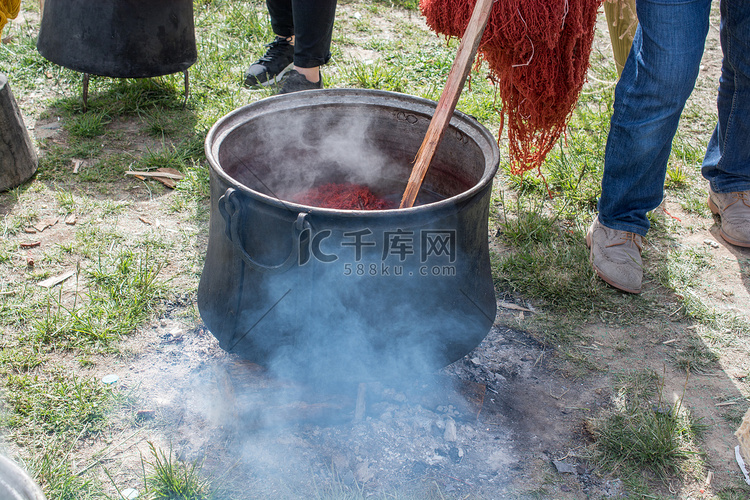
198,89,499,380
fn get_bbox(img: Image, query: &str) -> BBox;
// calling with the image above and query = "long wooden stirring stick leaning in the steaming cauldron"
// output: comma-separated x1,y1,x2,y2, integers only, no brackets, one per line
399,0,500,208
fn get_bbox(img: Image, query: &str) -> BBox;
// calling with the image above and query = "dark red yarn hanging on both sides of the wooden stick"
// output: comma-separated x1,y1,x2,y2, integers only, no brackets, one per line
420,0,603,174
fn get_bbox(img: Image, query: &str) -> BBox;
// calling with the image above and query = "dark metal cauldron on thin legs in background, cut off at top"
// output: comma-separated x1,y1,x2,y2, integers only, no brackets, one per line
37,0,198,78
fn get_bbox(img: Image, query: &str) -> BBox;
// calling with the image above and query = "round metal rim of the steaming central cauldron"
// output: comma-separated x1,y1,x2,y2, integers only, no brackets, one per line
205,89,500,218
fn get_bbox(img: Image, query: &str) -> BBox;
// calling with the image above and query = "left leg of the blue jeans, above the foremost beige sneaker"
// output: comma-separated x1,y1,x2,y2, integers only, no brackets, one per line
599,0,711,236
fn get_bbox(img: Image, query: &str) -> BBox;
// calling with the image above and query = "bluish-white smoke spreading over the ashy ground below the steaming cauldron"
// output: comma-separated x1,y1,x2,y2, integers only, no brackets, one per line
179,348,499,498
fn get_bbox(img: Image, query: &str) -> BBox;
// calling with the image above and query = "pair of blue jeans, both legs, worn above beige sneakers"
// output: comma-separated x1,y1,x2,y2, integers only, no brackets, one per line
599,0,750,236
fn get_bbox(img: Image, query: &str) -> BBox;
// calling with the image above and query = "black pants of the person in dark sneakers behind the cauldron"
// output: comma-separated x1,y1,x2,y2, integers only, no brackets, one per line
266,0,336,68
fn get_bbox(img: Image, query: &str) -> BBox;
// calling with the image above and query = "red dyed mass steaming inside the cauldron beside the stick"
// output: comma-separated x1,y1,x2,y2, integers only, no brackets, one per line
290,183,396,210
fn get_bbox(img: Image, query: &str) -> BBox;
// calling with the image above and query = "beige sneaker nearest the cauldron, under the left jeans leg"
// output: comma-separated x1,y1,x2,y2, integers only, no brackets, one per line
586,217,643,293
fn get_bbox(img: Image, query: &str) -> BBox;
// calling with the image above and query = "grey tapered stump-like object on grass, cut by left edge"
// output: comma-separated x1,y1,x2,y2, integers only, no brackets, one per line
0,73,38,192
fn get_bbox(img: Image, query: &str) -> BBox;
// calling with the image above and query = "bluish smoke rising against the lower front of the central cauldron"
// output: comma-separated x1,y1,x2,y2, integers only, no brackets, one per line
220,242,495,389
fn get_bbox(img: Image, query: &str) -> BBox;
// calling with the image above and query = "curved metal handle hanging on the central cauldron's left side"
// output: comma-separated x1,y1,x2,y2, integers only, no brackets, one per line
218,188,310,274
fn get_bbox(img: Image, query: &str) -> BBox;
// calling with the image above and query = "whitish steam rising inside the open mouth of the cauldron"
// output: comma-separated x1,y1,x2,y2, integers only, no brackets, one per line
224,107,408,204
